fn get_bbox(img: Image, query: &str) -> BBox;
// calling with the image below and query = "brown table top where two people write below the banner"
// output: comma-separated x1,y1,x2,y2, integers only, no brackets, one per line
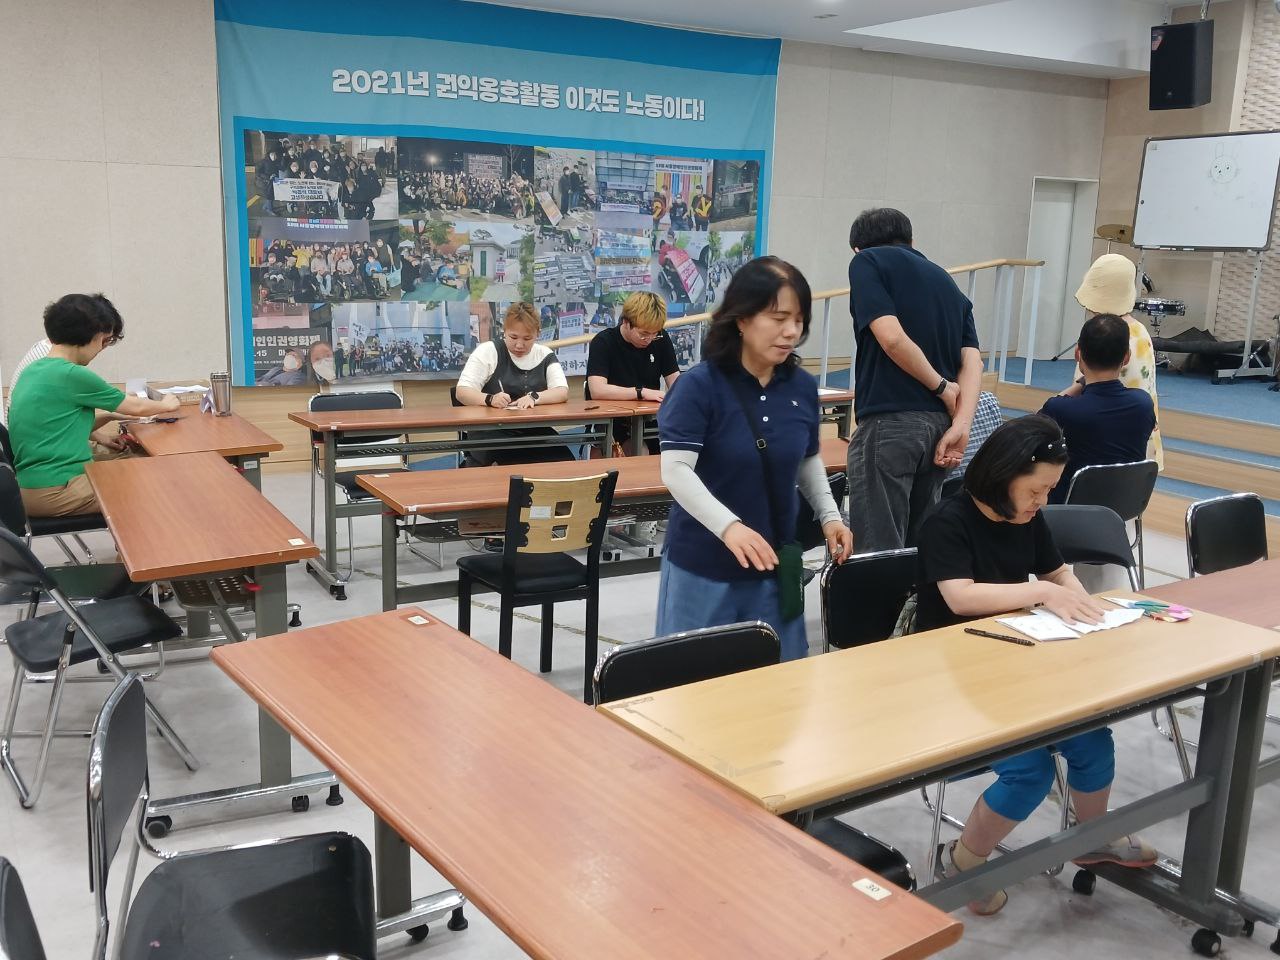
289,399,635,433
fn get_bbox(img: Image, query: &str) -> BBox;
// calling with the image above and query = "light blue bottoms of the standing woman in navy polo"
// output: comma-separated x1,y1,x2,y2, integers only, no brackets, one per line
655,557,809,660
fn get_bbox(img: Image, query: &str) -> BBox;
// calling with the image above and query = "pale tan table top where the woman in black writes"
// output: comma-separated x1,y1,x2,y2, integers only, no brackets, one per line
600,599,1280,813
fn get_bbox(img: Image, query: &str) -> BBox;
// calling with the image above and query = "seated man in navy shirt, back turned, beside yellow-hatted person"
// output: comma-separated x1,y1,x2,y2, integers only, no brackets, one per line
1041,314,1156,503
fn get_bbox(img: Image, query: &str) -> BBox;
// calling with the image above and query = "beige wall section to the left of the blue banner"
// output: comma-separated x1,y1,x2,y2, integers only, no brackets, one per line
0,0,227,380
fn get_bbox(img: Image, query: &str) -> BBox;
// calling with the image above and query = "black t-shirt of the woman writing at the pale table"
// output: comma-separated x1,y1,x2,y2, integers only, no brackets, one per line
915,493,1062,630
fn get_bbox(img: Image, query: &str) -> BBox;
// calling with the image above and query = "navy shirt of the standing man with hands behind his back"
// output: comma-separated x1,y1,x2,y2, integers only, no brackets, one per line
849,244,978,417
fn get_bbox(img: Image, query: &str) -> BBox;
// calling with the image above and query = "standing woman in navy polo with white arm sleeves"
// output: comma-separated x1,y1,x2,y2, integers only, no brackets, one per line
657,257,854,659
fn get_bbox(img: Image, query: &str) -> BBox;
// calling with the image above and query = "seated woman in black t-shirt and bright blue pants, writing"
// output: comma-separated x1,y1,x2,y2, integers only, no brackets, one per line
916,415,1156,915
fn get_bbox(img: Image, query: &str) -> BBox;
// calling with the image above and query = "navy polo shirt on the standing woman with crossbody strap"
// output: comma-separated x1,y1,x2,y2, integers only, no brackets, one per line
658,361,818,581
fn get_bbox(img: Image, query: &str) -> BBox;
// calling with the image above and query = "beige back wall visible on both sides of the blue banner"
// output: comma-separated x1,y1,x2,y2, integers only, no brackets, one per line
0,0,1111,380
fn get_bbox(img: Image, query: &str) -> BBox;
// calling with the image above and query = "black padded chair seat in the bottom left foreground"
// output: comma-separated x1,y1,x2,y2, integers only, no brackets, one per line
122,833,378,960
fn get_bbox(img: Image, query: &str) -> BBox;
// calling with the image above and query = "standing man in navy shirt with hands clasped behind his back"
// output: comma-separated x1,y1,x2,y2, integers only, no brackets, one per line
849,207,982,552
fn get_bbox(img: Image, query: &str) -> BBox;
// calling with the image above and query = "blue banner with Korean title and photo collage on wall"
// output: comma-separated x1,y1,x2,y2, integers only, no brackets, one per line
215,0,780,385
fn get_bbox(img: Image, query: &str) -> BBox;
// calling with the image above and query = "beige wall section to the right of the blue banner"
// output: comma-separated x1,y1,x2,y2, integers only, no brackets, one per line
769,42,1107,355
